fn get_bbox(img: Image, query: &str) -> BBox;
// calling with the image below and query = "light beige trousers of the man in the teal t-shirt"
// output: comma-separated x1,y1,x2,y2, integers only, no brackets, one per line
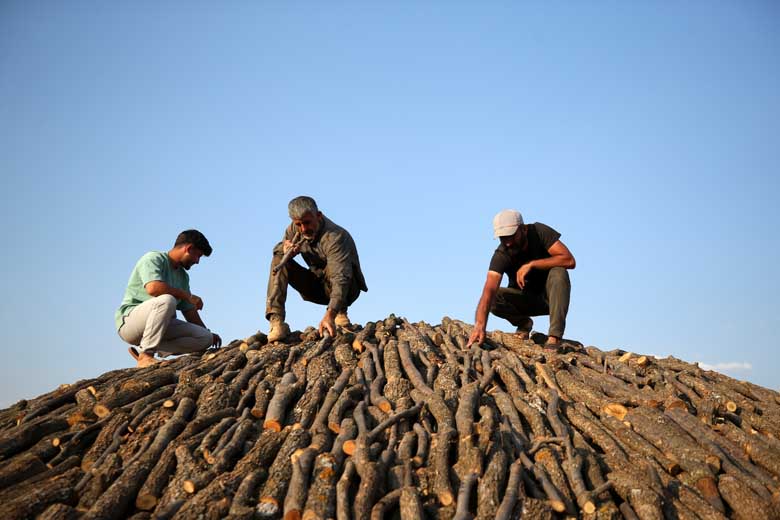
119,294,212,356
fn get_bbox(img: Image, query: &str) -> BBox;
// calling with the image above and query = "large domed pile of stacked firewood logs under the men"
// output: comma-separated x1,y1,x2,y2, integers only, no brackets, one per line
0,315,780,520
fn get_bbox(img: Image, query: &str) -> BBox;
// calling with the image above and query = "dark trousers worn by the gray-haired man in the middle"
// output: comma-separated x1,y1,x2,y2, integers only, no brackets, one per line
265,255,360,319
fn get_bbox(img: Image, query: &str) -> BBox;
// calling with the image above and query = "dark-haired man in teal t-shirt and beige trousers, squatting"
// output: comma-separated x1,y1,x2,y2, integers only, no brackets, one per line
114,229,222,367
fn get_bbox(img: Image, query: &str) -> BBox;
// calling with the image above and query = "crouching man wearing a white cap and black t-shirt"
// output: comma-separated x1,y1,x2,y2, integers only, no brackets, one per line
468,209,576,349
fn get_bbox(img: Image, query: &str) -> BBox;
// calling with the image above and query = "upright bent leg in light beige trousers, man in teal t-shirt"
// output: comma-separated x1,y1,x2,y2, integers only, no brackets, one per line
119,294,176,352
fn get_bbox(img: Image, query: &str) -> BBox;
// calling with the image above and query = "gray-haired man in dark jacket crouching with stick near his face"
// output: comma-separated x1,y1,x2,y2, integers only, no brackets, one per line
265,196,368,341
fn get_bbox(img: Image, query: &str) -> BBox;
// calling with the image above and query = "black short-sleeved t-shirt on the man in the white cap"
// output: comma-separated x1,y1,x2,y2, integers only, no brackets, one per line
490,222,561,292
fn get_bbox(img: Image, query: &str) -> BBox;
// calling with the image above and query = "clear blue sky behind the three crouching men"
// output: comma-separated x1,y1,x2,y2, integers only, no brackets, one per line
0,0,780,406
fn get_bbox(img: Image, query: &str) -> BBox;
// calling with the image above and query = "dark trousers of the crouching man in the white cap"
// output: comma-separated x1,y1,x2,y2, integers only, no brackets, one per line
490,267,571,338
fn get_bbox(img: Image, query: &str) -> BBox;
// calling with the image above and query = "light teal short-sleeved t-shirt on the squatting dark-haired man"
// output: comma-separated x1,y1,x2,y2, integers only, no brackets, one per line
114,251,195,330
